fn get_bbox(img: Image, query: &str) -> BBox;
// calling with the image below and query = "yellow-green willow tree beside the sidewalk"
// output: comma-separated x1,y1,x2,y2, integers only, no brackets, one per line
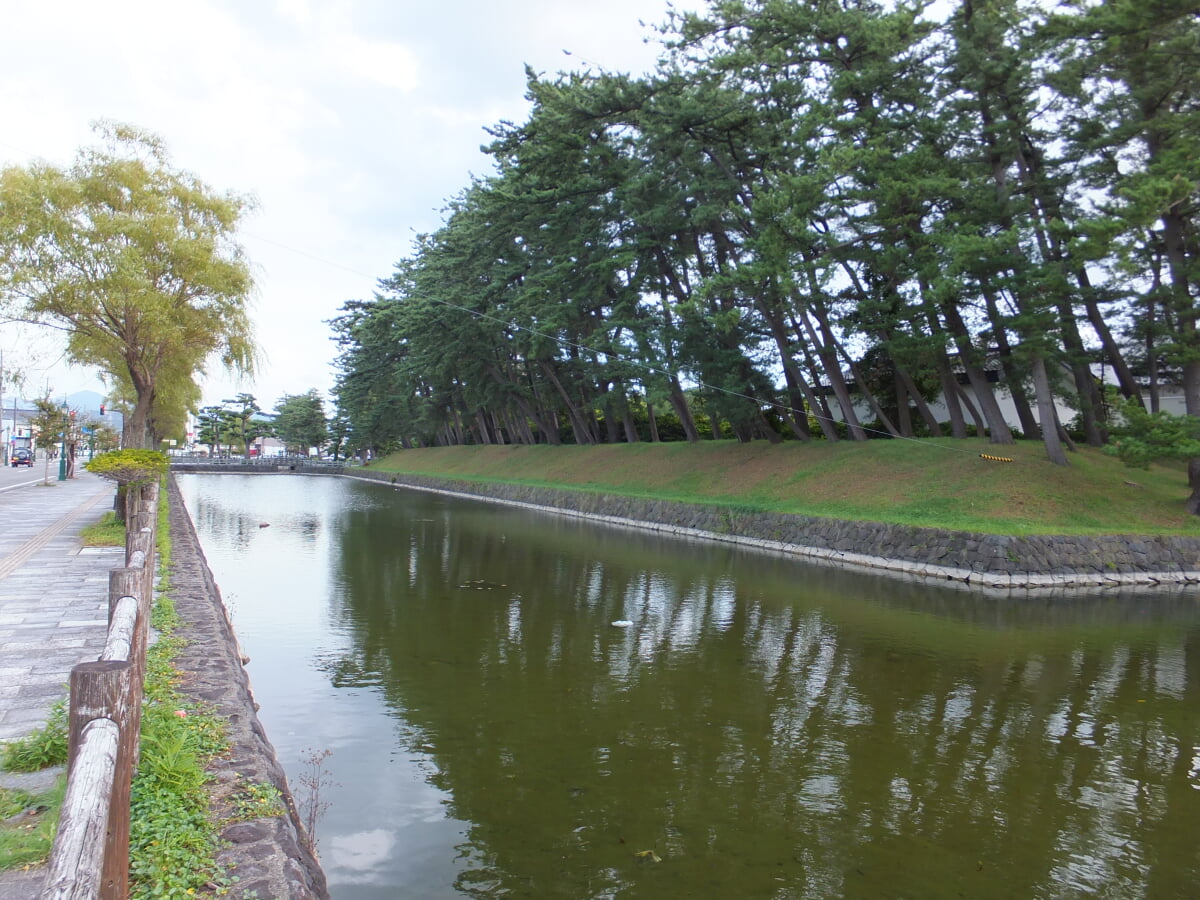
0,122,254,446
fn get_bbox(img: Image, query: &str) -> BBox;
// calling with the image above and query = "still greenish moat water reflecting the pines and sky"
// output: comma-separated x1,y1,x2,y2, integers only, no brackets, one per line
179,475,1200,900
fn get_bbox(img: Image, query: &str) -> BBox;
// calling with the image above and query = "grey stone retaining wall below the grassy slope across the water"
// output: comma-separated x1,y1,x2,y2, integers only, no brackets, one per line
346,469,1200,589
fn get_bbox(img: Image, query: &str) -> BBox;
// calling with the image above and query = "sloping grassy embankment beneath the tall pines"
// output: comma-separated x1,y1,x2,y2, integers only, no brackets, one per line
371,438,1200,535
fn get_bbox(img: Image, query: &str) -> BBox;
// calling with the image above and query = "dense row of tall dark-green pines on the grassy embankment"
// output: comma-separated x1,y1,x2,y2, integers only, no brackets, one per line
332,0,1200,472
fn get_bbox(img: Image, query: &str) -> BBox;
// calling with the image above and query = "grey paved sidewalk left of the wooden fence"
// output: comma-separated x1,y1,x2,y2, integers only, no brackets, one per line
0,469,125,900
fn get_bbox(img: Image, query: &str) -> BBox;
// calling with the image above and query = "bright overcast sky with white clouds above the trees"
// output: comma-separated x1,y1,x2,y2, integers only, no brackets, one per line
0,0,703,409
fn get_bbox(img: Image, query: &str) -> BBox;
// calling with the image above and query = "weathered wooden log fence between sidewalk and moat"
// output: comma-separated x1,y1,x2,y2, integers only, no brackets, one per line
41,484,158,900
